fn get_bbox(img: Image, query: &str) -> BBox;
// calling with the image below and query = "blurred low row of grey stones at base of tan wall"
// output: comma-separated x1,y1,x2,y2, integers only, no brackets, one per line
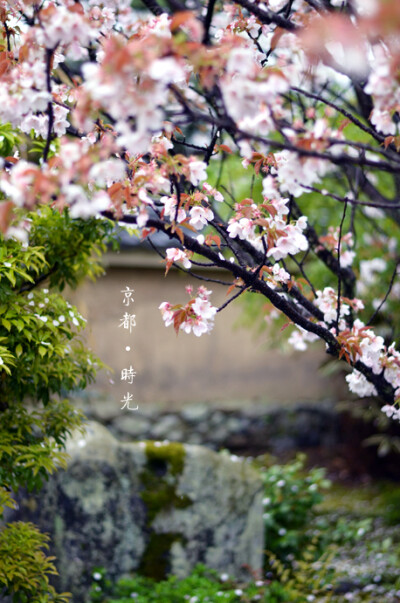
79,400,339,454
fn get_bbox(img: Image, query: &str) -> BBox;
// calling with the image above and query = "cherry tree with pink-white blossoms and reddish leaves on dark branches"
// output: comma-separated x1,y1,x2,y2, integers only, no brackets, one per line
0,0,400,417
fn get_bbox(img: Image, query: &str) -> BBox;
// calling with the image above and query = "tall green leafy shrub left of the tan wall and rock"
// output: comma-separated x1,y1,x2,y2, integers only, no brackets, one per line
0,206,112,603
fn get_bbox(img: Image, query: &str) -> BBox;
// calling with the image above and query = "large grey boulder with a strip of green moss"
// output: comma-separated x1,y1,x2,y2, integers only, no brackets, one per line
8,422,263,601
